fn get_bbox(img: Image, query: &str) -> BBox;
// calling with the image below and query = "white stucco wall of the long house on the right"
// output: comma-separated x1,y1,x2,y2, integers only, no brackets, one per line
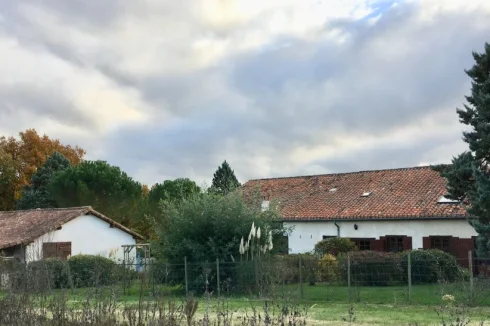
284,220,477,253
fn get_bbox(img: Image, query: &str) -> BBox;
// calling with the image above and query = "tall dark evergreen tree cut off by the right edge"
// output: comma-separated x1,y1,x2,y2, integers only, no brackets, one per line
435,43,490,257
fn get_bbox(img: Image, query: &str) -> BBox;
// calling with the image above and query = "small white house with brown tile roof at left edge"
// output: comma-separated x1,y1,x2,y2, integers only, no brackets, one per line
0,206,143,262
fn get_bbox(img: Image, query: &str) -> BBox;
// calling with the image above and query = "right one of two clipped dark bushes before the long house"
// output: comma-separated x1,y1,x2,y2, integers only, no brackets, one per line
400,249,464,283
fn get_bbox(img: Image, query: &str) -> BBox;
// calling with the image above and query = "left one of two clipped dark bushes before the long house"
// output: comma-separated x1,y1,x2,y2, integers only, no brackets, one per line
339,250,403,286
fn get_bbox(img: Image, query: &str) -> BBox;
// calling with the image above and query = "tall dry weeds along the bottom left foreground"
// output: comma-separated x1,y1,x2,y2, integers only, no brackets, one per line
0,278,307,326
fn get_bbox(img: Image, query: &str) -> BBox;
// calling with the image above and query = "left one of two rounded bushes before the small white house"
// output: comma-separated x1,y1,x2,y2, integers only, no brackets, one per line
25,258,73,291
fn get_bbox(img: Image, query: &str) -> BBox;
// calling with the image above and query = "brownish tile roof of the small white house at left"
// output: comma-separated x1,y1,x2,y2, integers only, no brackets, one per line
0,206,143,249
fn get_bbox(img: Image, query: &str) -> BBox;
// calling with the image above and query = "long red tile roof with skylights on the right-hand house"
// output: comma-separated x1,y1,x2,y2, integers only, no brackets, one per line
243,166,467,220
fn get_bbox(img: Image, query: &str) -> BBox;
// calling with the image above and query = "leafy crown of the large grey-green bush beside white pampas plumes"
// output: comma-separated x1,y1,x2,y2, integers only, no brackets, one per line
156,193,283,263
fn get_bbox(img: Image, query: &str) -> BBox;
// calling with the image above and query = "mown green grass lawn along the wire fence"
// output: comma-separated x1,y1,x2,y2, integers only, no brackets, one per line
0,282,490,326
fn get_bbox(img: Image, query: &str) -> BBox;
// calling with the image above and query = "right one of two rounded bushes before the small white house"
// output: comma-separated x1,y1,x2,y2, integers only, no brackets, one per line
68,255,118,287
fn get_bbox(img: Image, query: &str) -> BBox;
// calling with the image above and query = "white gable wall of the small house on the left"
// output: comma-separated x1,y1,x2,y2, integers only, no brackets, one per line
26,215,136,262
